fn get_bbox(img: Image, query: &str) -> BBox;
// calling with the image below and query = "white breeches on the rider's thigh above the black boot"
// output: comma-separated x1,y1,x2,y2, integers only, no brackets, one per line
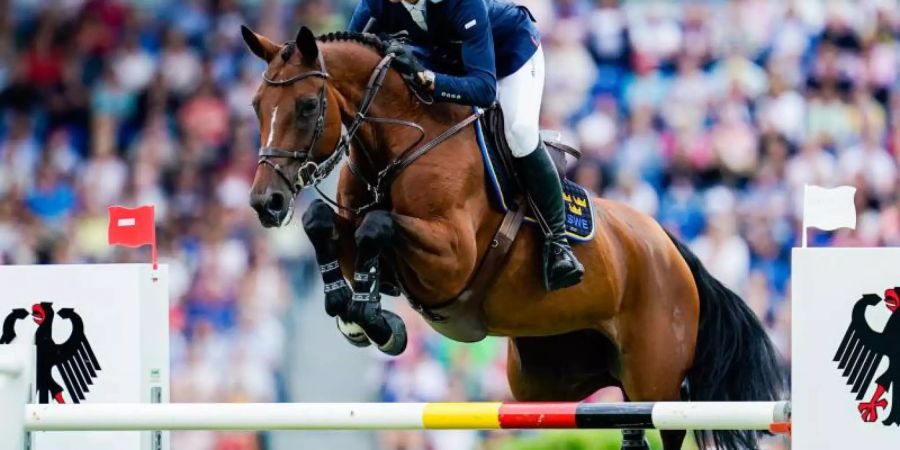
497,46,544,158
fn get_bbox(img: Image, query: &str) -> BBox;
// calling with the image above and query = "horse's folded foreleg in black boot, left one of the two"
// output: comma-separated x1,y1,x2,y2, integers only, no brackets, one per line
303,200,369,347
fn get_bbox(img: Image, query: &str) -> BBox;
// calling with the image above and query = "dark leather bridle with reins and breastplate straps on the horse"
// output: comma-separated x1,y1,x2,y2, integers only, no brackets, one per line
257,42,483,215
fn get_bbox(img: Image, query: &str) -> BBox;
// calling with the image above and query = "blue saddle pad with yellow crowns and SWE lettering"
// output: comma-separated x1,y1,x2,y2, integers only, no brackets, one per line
475,116,594,244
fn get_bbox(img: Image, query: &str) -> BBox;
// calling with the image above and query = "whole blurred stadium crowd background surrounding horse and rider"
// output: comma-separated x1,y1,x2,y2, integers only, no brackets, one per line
0,0,900,450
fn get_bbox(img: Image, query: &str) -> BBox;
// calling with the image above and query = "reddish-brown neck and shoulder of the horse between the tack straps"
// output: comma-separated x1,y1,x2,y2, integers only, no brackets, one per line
326,44,502,300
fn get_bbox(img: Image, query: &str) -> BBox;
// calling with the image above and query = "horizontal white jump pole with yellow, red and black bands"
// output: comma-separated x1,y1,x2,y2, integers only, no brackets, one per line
25,402,790,431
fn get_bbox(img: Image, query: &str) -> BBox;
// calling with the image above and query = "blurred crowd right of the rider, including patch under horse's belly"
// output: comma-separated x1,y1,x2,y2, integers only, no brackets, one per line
382,0,900,449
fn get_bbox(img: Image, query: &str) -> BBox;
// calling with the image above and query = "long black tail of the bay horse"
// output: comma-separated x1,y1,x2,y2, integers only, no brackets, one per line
669,234,784,450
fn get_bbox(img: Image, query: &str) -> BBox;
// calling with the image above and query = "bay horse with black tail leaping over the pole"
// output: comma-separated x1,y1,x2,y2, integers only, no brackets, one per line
242,27,783,450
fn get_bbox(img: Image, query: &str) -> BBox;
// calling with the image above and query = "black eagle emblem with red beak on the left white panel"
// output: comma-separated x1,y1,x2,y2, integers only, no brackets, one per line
0,302,100,403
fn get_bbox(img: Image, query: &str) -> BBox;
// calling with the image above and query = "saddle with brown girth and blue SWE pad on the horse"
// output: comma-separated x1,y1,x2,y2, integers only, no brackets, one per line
398,105,594,342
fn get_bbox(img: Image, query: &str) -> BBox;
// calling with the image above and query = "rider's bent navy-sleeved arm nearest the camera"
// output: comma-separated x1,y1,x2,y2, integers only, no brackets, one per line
430,0,497,108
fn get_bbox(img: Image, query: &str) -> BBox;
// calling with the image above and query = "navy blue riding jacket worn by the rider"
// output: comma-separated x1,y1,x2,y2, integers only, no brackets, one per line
349,0,540,107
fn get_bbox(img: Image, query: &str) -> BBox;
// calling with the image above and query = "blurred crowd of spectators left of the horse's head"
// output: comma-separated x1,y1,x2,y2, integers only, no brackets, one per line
0,0,309,450
